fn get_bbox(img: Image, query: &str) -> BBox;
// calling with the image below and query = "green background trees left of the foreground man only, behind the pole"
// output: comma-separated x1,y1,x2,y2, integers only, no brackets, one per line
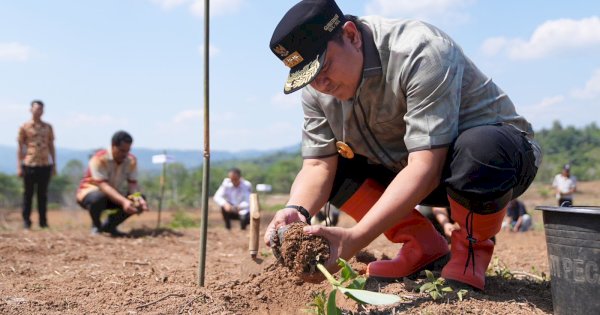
0,152,302,209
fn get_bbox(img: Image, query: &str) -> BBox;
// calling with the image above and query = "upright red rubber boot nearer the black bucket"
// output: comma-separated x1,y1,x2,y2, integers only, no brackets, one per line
442,197,506,290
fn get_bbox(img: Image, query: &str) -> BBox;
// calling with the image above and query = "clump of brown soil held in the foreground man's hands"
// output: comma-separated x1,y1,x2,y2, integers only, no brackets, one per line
279,222,329,275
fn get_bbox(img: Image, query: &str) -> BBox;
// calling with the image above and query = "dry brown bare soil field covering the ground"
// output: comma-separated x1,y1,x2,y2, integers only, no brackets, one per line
0,183,600,314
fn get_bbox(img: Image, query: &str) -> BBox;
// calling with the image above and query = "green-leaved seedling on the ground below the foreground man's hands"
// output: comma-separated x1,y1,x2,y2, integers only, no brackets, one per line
309,258,400,315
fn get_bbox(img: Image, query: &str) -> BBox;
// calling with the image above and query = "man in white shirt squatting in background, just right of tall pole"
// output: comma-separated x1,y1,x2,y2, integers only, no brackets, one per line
213,168,252,230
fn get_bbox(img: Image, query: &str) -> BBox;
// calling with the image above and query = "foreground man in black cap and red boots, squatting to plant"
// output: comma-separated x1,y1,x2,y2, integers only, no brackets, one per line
265,0,541,289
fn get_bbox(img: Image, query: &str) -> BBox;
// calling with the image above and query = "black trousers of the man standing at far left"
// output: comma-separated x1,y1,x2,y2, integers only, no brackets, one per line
23,166,52,227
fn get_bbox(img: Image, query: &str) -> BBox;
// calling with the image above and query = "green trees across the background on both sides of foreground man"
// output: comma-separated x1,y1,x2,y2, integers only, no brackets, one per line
0,121,600,209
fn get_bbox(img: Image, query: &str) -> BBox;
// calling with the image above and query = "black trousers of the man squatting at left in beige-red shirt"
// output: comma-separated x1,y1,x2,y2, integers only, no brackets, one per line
80,190,131,232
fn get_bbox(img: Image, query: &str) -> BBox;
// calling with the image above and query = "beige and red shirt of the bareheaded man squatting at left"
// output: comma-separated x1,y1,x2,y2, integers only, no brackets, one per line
77,147,137,202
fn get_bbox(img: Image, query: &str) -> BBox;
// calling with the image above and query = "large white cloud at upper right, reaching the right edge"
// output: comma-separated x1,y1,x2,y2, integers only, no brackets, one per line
481,16,600,60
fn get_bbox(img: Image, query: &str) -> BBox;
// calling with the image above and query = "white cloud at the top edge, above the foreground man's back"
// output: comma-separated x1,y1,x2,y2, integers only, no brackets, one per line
365,0,476,24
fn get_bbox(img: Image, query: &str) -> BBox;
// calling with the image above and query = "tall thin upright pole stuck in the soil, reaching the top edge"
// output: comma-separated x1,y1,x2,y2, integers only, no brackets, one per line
198,0,210,287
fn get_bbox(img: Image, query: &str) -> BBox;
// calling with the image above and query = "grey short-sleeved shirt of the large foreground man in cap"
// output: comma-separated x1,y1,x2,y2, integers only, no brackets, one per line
302,17,541,172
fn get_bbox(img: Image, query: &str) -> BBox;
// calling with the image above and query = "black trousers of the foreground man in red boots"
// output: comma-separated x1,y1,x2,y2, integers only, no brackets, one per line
330,124,537,214
